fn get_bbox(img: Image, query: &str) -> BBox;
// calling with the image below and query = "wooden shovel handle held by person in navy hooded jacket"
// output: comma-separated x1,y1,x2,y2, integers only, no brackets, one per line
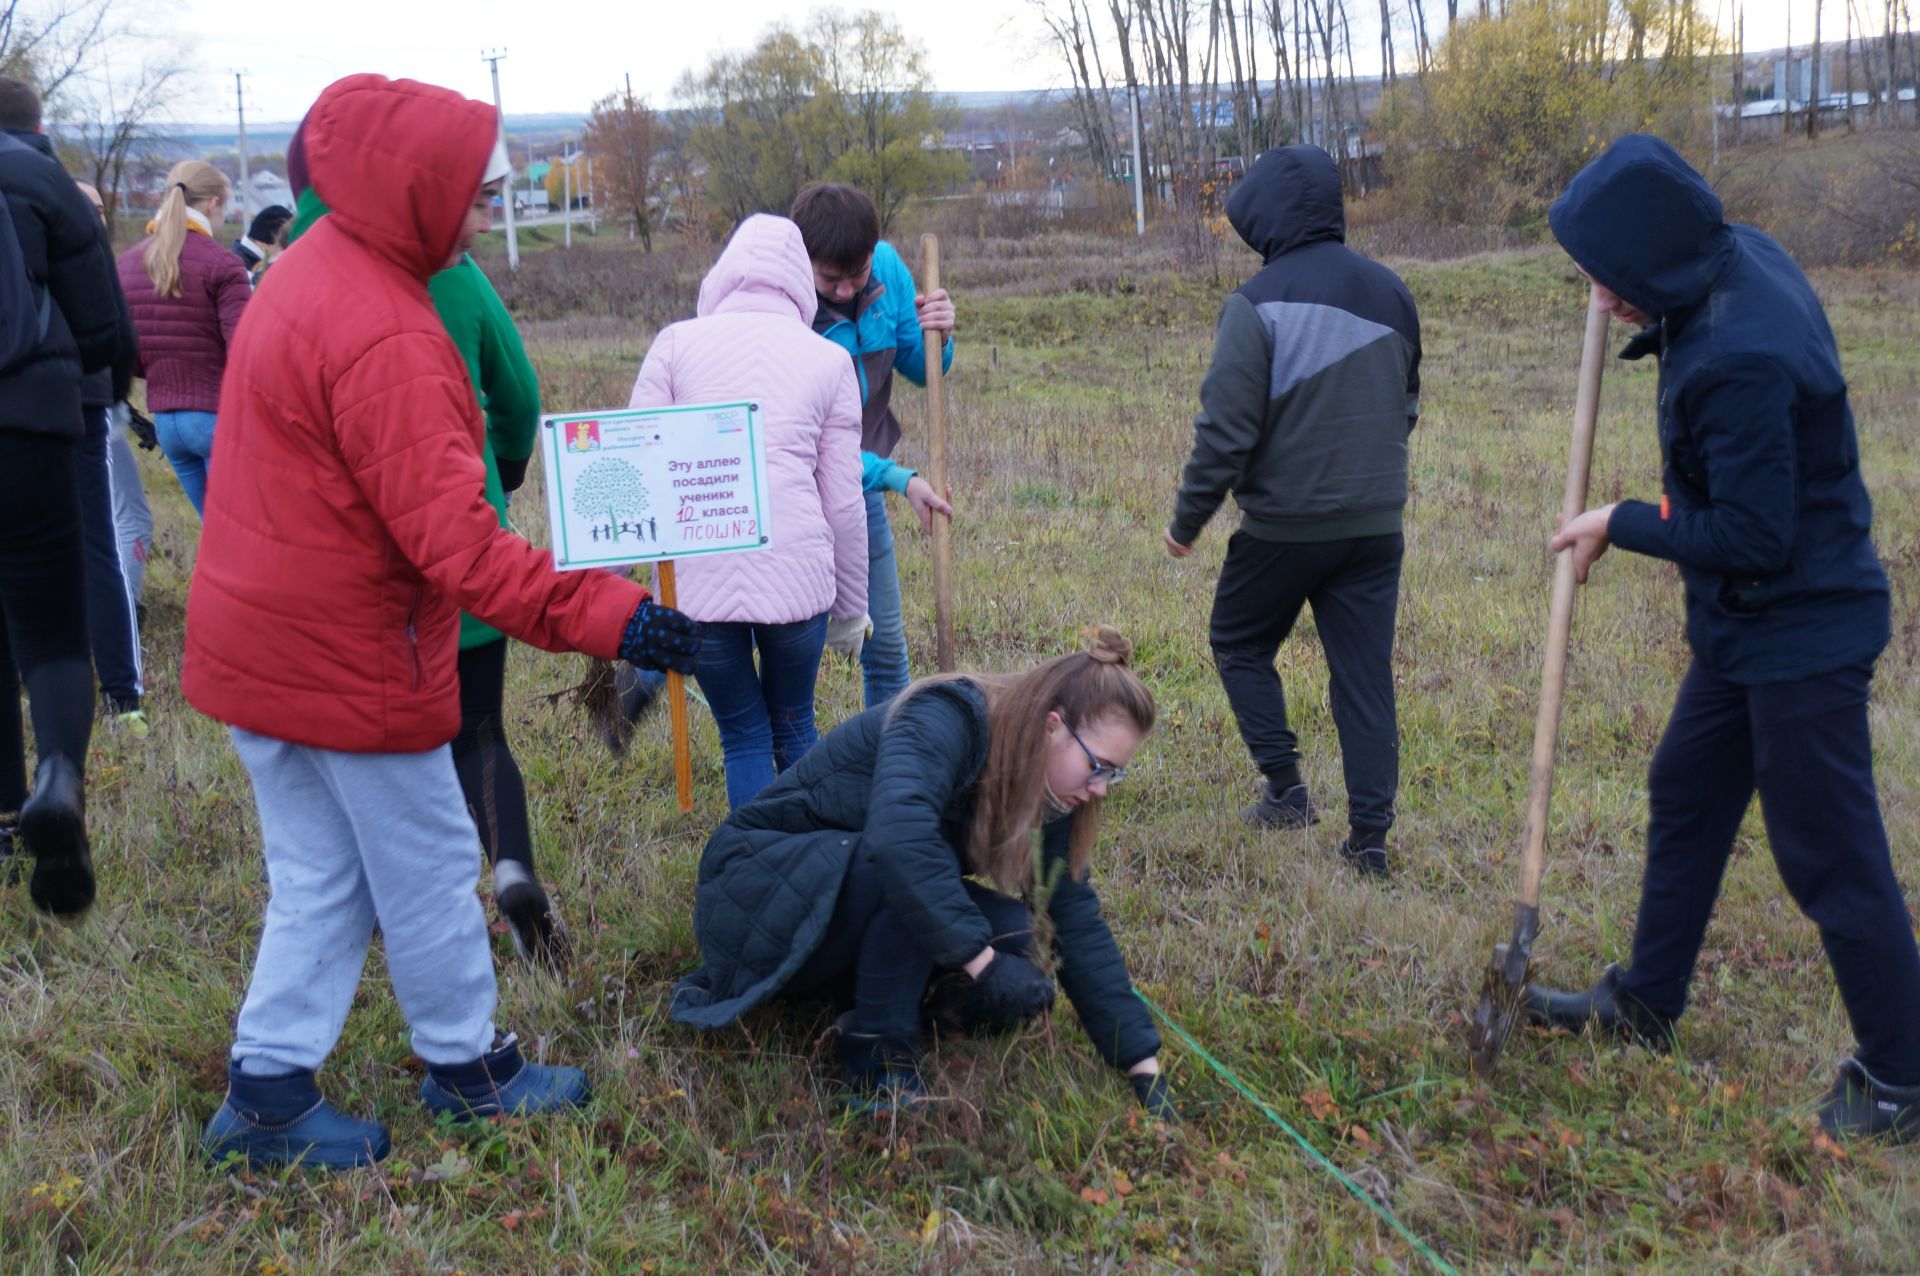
1519,287,1609,908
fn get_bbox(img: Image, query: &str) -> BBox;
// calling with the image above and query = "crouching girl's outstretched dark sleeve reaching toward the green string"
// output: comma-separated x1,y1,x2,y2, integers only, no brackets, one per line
1041,817,1160,1071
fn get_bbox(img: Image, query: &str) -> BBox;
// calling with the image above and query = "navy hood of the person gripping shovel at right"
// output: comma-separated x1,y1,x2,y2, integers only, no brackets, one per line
1548,132,1734,319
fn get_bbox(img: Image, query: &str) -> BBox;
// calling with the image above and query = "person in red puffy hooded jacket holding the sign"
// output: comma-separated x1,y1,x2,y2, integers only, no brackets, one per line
180,75,699,1165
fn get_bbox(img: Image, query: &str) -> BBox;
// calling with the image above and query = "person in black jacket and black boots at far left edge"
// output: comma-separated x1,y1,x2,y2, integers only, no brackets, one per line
0,77,121,915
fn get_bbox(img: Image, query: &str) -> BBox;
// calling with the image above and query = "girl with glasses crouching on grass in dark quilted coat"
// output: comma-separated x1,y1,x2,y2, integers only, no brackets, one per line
672,627,1175,1117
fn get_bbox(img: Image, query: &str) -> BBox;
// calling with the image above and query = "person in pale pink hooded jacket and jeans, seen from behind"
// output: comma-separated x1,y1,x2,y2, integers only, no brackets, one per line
632,215,866,808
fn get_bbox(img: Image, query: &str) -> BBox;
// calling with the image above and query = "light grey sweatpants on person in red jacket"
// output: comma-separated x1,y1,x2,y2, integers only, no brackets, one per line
232,727,497,1073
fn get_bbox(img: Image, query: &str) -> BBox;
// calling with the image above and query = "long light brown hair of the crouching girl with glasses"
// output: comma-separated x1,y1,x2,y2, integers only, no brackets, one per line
902,626,1154,894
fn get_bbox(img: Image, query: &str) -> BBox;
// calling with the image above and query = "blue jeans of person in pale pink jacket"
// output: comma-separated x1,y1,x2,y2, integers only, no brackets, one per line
695,616,828,810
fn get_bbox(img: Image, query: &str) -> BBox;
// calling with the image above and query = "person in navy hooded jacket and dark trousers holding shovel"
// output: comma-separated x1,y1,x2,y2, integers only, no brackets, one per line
1528,136,1920,1142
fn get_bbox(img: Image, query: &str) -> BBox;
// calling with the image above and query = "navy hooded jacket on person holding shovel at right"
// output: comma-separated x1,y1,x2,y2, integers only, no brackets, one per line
1549,134,1891,685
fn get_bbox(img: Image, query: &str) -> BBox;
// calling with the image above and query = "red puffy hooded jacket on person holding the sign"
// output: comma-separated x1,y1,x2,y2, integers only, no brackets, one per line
180,75,647,752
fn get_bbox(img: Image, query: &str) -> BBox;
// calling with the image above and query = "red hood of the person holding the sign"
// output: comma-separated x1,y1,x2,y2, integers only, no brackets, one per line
290,75,499,280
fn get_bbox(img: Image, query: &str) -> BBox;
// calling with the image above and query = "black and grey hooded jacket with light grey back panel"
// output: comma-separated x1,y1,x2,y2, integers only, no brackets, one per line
1167,146,1421,545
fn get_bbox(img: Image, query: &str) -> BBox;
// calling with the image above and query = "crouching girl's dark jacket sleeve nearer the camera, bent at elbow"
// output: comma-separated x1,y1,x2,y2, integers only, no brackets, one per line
860,689,993,967
